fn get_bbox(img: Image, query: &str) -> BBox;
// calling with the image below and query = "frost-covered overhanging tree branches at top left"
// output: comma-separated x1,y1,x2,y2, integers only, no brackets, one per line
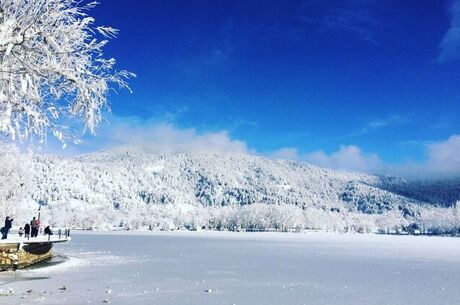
0,0,134,141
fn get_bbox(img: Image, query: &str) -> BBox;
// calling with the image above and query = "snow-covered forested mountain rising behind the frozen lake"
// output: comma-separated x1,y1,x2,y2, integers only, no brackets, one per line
0,147,460,230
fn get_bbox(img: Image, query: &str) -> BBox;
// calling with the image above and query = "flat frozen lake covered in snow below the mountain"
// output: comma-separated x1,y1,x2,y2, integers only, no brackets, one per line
0,232,460,305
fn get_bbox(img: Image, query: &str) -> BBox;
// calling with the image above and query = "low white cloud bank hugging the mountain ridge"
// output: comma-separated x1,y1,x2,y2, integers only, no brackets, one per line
38,116,460,178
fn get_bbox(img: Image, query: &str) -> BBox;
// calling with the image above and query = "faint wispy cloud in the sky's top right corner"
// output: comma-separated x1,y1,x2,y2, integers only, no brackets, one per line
438,0,460,62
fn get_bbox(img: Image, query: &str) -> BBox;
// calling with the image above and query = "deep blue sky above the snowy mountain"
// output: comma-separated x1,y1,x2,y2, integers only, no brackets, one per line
58,0,460,174
